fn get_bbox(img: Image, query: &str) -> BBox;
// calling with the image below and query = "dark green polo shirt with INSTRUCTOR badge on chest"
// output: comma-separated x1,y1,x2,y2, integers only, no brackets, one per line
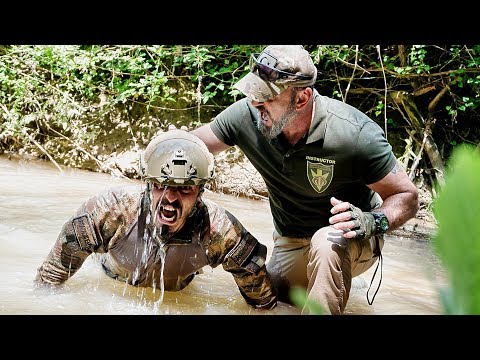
211,90,396,237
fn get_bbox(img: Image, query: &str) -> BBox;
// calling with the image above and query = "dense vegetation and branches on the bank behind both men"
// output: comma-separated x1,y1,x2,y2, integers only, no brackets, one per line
0,45,480,200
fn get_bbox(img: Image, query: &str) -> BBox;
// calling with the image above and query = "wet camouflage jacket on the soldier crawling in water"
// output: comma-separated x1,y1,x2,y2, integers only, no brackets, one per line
35,185,276,309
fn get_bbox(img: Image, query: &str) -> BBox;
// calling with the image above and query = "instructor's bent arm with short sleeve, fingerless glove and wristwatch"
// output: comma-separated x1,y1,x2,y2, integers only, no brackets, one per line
329,116,418,238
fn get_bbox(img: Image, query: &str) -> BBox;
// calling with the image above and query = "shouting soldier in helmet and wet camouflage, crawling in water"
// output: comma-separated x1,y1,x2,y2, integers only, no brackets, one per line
35,129,277,309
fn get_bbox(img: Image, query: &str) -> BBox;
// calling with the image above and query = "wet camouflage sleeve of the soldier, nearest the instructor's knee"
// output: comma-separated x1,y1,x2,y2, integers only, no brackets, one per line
203,201,277,309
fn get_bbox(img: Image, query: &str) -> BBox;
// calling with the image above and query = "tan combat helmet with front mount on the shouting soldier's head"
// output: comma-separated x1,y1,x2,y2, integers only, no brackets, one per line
140,126,214,186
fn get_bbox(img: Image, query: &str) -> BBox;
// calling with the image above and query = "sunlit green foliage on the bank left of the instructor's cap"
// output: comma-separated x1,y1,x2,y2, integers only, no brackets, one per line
0,45,259,160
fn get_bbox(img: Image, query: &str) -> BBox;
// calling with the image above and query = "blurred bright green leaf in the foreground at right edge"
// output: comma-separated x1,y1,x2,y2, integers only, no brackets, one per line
433,144,480,314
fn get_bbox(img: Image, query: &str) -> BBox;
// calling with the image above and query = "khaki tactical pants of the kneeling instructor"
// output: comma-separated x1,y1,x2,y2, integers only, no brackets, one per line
267,226,384,315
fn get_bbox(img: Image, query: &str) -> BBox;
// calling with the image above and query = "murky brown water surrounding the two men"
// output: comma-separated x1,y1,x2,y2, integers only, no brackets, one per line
0,156,446,315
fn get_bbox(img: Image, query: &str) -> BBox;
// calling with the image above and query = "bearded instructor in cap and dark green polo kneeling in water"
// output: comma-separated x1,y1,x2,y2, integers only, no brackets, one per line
193,45,418,314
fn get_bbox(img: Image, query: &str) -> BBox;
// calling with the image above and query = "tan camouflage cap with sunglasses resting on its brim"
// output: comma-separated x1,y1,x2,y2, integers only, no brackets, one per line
234,45,317,102
